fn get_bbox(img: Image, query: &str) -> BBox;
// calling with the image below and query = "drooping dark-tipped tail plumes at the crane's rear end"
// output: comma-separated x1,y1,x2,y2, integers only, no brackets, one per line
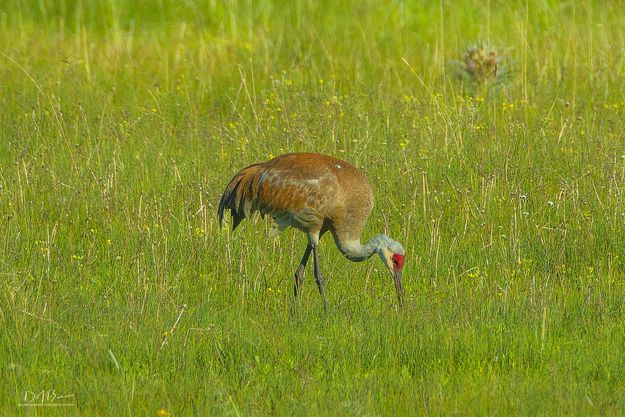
217,164,262,230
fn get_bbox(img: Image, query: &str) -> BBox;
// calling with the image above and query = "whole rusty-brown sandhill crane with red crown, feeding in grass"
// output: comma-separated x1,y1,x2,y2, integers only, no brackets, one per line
218,153,405,308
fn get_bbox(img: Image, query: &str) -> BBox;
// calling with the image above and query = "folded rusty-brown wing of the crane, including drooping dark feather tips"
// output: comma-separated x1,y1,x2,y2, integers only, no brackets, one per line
218,161,337,230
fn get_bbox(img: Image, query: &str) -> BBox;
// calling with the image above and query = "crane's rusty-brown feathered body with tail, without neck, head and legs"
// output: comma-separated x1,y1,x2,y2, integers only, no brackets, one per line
219,153,373,238
